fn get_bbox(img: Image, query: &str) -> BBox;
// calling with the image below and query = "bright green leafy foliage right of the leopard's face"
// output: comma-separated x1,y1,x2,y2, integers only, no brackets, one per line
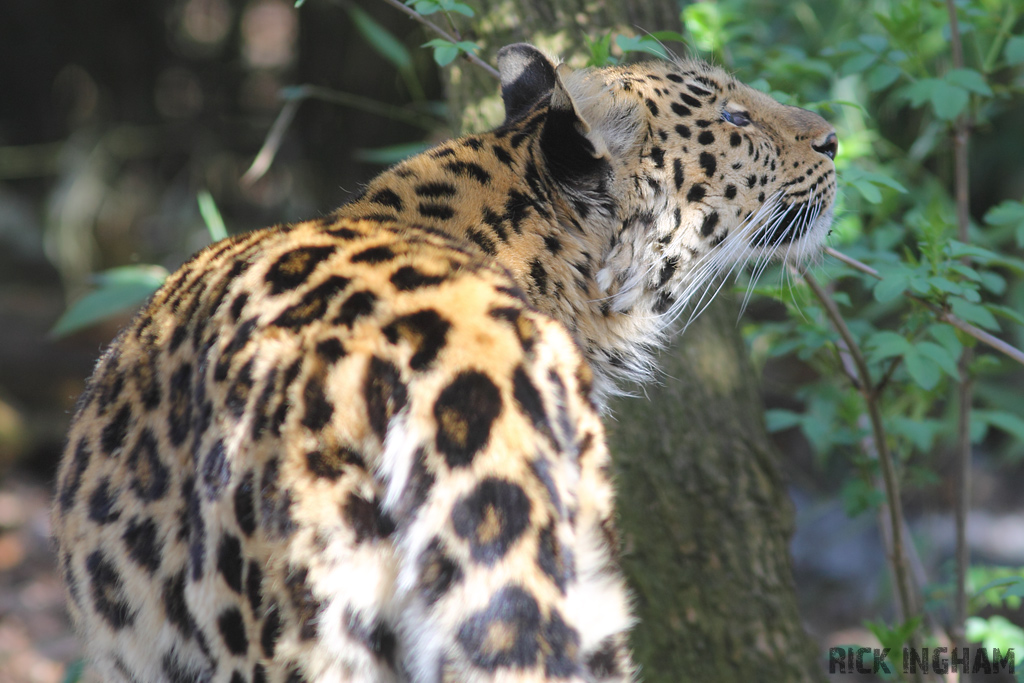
696,0,1024,651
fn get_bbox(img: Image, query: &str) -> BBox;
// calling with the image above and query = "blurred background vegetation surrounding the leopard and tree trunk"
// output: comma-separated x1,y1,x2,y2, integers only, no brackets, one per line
0,0,1024,682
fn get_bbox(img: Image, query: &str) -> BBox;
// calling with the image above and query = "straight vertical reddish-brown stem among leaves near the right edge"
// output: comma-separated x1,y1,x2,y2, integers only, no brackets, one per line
946,0,973,647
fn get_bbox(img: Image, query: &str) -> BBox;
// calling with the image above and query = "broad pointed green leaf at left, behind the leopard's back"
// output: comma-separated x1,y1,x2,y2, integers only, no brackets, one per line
50,265,167,337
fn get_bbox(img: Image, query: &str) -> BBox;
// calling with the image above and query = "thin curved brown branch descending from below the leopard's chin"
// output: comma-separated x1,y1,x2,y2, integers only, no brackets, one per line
796,272,921,680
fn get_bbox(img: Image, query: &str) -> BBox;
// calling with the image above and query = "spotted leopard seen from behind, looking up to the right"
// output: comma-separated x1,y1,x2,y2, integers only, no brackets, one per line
52,44,838,683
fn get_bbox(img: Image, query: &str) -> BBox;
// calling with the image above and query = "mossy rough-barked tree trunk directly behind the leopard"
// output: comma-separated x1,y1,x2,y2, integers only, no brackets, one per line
447,0,821,683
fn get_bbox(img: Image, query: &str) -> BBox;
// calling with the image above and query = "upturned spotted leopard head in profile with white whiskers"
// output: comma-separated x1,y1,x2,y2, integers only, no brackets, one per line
499,44,838,329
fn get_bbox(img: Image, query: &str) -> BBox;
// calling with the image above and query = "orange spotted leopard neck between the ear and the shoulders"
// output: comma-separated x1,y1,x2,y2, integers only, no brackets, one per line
338,125,668,395
